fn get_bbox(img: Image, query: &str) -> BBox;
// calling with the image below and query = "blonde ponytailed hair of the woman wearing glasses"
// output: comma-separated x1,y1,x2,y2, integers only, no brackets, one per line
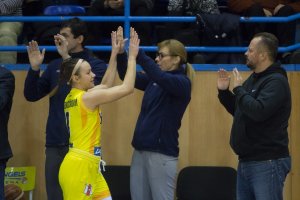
157,39,195,85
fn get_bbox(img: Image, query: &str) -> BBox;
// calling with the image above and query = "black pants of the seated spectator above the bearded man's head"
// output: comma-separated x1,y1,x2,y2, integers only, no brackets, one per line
241,4,296,46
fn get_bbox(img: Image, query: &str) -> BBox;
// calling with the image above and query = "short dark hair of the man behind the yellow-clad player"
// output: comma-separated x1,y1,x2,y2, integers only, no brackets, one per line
60,17,88,46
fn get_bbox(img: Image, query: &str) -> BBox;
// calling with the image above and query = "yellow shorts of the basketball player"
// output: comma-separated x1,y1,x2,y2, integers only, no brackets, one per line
59,148,111,200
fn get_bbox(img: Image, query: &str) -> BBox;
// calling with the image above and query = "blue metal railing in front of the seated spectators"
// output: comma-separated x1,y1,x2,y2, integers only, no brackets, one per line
0,0,300,70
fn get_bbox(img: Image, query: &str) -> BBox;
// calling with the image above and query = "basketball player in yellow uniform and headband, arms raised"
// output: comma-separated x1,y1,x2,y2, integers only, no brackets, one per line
50,28,140,200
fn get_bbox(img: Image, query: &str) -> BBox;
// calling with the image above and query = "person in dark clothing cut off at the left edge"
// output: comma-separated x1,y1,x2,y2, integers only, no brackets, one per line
0,67,15,199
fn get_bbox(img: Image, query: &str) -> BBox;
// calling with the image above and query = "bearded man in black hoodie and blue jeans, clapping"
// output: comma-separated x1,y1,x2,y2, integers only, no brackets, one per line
218,33,291,200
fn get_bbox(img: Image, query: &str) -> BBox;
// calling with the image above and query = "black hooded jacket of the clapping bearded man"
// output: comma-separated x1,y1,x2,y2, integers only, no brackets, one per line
219,64,291,161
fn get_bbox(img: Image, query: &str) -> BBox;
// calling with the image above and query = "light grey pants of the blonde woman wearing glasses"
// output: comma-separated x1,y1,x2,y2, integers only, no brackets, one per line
130,150,178,200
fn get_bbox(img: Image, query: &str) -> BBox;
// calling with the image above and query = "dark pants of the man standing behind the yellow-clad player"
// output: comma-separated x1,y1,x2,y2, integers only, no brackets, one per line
45,146,69,200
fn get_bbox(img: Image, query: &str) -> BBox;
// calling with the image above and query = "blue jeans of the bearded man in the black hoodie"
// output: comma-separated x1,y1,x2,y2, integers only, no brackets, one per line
237,157,291,200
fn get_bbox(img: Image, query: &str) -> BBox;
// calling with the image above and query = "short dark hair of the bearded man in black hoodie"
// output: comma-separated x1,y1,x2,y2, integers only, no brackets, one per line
254,32,278,61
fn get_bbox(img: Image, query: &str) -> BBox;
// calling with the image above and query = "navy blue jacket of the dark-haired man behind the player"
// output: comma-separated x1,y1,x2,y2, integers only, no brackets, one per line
24,49,106,147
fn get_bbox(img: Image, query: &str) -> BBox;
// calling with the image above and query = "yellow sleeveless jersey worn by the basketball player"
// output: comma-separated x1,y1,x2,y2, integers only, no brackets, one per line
64,88,102,156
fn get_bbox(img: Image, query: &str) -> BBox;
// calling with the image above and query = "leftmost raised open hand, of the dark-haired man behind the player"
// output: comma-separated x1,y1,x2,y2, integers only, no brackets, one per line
27,40,45,71
